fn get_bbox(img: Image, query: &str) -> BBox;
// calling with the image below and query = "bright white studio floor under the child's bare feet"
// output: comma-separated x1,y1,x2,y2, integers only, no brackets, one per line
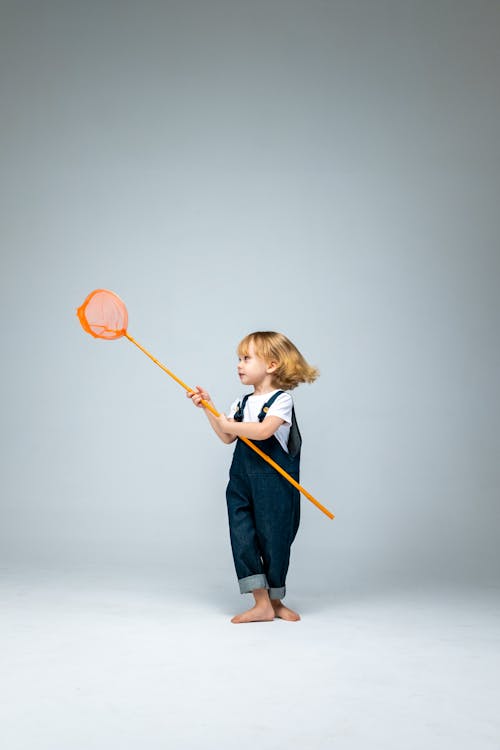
0,569,500,750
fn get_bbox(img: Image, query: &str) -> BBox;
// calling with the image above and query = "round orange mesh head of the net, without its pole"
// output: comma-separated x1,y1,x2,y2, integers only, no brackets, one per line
76,289,128,340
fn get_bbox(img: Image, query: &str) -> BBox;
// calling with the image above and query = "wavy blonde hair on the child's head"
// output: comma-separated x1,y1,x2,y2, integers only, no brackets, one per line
237,331,319,391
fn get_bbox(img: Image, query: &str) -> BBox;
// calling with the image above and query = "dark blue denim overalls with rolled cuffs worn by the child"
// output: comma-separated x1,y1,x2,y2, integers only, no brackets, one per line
226,391,302,599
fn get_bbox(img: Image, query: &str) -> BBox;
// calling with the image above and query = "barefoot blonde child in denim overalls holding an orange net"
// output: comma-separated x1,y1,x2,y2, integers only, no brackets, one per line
187,331,319,623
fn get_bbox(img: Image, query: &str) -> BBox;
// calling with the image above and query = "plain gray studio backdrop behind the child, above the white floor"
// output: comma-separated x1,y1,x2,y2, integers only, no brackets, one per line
0,0,500,592
